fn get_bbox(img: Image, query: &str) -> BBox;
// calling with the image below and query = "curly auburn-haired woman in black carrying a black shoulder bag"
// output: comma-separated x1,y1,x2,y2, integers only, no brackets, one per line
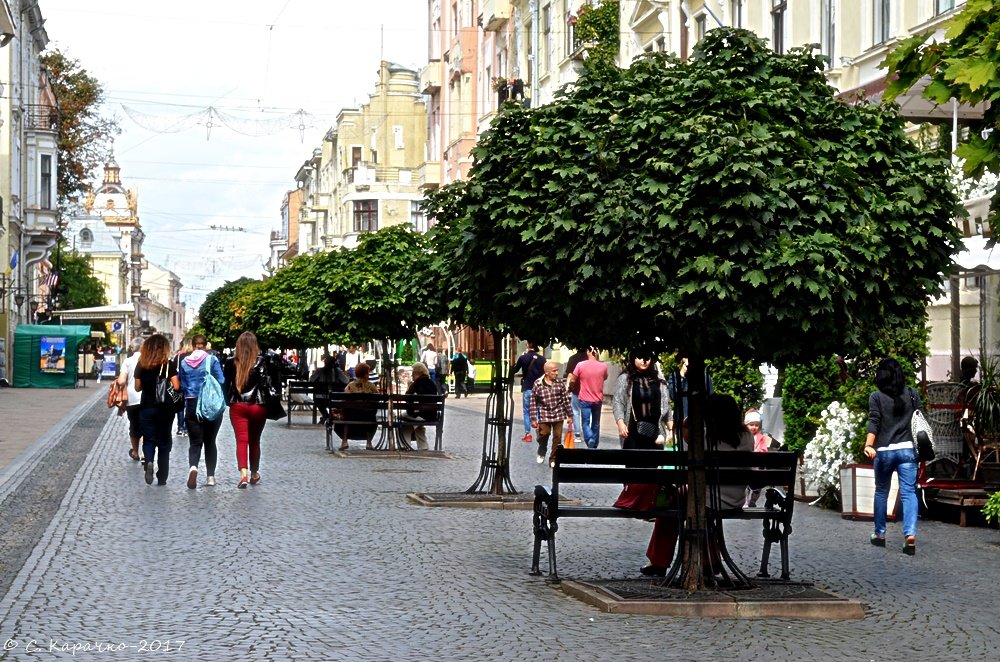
134,333,181,485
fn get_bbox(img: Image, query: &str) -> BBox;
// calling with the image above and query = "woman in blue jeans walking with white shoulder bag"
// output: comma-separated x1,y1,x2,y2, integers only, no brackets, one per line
865,358,923,556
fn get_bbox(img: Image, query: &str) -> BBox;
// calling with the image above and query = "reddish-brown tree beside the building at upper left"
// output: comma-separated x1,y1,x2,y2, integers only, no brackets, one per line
41,49,121,206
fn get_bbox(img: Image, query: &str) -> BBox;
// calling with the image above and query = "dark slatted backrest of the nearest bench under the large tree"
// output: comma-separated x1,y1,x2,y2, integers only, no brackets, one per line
552,448,798,504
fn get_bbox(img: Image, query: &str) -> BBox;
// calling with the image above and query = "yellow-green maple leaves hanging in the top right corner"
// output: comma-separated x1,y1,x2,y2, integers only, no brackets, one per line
884,0,1000,176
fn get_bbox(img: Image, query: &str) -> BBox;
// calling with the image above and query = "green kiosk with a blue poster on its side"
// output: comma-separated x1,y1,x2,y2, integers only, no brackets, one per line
14,324,90,388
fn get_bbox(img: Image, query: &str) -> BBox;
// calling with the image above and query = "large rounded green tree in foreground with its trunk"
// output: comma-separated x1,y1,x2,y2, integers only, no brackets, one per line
431,29,958,588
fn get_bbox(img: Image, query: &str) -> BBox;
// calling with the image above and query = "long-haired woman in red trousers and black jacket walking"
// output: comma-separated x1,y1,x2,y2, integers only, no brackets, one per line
223,331,280,489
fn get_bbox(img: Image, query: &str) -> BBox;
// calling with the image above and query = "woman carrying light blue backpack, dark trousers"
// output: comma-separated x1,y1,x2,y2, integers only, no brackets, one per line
177,334,226,490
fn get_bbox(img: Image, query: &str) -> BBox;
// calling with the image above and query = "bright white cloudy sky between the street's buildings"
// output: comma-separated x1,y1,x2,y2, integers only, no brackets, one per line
40,0,427,314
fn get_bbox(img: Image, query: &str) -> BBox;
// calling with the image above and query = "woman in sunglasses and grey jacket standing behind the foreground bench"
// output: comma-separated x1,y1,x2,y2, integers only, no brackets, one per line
612,349,670,450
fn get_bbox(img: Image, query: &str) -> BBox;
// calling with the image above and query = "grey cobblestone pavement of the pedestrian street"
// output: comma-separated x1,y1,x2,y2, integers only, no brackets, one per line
0,398,1000,662
